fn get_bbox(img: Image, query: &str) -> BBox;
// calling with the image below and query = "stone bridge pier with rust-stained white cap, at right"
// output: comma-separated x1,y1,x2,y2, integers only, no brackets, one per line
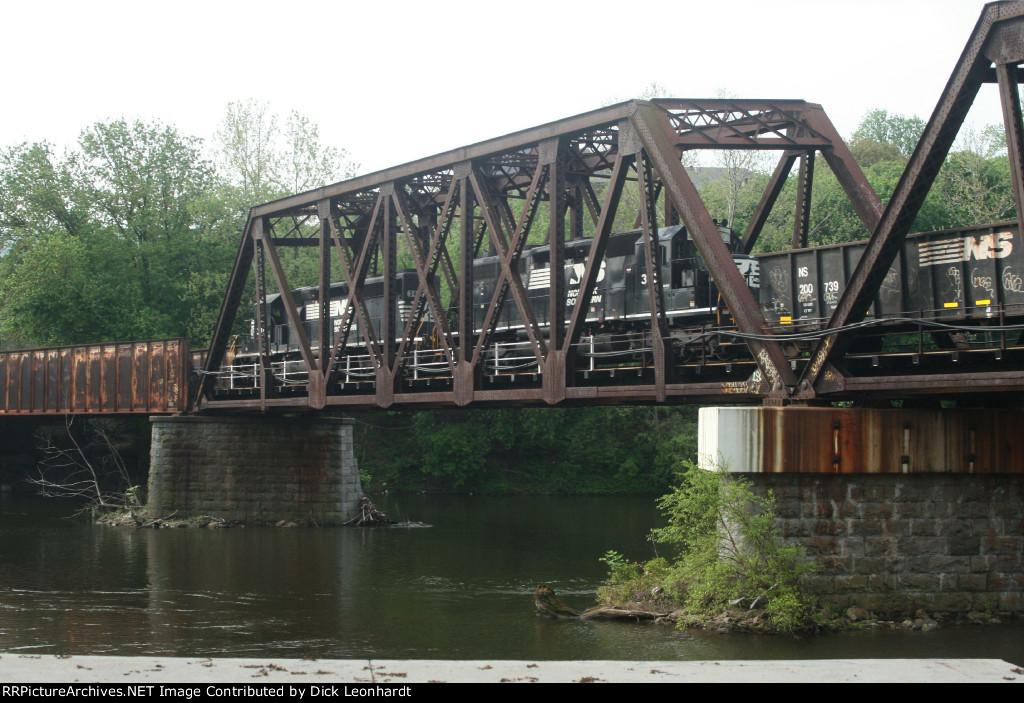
698,407,1024,615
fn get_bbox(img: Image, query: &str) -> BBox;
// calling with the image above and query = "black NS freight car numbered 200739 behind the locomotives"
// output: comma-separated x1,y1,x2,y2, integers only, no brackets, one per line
758,223,1024,324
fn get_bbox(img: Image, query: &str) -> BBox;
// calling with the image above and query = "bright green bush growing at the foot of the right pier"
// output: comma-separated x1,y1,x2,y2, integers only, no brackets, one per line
598,462,815,630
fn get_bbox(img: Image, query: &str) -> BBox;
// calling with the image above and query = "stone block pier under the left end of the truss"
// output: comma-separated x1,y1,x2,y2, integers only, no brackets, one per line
148,415,362,525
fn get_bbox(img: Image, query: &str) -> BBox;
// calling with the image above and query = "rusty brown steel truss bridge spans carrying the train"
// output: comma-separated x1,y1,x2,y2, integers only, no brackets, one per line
196,2,1024,410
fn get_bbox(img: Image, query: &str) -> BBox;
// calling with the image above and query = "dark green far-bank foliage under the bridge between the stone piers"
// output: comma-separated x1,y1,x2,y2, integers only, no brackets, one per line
355,407,696,494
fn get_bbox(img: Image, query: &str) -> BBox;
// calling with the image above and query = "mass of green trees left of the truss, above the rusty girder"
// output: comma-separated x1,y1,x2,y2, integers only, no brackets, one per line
0,102,353,348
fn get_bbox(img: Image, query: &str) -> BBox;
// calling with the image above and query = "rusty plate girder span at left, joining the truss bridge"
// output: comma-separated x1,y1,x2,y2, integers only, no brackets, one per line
0,339,193,416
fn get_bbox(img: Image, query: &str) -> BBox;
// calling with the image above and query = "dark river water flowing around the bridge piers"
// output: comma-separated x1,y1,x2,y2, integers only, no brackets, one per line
0,494,1024,665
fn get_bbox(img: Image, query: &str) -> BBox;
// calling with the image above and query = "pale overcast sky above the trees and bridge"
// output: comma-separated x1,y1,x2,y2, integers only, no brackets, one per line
0,0,1000,173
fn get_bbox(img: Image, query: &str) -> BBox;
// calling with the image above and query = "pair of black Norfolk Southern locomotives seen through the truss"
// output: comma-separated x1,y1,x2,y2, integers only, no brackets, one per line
243,222,758,358
